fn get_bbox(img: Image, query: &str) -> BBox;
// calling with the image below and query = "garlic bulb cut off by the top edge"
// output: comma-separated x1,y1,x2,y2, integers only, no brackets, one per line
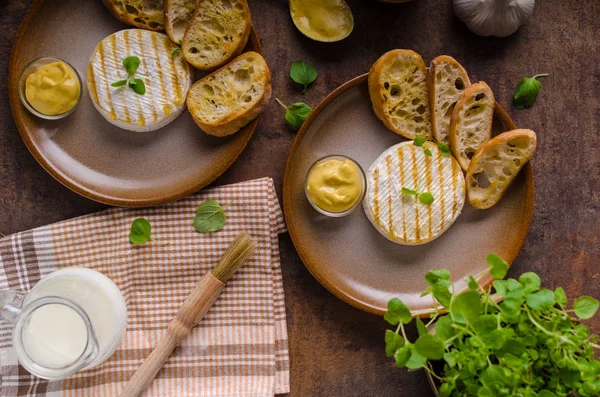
454,0,535,37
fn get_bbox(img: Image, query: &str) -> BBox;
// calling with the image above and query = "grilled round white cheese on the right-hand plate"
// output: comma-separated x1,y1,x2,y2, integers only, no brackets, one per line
363,141,465,245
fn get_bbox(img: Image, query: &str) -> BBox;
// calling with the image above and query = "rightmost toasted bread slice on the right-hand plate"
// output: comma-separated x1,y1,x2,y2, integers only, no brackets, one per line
467,130,537,209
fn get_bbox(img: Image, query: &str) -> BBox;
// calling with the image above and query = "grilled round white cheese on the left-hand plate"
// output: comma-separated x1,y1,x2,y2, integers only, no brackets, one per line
87,29,193,131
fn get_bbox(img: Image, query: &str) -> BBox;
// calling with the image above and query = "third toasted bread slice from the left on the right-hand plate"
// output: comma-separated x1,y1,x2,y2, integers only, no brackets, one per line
448,81,495,171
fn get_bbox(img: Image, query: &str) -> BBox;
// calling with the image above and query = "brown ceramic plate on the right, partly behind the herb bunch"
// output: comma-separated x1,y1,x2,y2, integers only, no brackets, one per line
283,74,533,315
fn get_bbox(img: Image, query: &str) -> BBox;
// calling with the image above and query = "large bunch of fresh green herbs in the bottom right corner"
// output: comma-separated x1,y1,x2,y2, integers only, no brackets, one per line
384,254,600,397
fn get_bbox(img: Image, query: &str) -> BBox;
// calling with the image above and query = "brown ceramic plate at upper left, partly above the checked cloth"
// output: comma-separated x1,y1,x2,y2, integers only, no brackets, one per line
9,0,262,207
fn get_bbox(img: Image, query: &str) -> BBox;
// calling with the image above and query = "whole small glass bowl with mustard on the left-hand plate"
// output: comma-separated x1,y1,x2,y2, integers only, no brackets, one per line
19,57,83,120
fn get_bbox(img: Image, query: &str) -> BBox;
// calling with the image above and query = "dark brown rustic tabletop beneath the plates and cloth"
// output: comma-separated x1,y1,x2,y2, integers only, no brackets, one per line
0,0,600,397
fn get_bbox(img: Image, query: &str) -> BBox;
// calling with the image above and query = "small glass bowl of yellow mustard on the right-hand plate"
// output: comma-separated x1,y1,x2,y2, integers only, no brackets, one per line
304,155,367,217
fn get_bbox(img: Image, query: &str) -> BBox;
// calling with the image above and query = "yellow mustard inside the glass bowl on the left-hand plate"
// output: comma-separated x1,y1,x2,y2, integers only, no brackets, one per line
25,61,81,116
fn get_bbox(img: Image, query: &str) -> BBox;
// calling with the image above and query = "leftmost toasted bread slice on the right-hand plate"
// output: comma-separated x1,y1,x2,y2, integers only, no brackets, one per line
369,50,431,139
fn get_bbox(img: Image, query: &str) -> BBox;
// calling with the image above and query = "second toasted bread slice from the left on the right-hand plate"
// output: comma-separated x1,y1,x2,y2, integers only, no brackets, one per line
428,55,471,144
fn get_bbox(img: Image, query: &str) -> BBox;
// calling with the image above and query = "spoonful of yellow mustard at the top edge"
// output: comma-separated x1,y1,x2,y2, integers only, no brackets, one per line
290,0,354,41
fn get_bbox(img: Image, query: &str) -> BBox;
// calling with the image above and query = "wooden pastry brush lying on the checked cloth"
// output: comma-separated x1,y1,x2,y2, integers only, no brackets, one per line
120,232,256,397
